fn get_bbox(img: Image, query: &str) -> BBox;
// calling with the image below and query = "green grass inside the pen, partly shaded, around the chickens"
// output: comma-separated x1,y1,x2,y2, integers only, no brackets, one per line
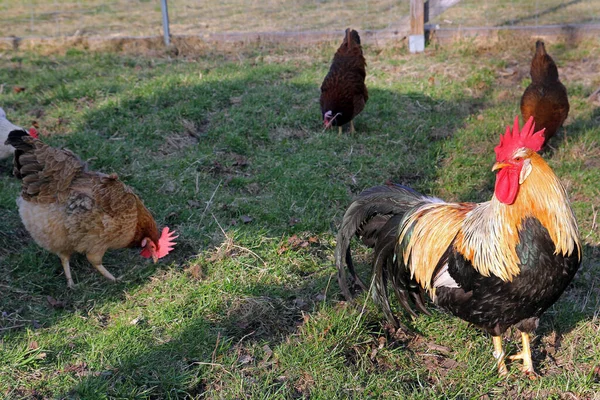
0,39,600,399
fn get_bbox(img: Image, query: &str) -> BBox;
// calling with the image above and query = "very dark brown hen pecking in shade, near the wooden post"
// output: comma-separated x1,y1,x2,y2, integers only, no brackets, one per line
320,28,369,134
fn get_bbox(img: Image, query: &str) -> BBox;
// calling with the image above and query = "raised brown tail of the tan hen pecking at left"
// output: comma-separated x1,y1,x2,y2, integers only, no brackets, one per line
5,130,85,203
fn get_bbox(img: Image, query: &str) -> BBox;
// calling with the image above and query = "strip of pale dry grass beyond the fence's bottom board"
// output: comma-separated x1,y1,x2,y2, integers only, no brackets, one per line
0,0,600,38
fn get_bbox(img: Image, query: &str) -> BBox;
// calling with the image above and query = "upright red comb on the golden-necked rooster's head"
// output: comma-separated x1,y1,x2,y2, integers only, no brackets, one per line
494,115,546,161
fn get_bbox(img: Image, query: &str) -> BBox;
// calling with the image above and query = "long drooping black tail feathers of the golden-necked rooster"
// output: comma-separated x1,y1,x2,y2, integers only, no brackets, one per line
335,185,427,324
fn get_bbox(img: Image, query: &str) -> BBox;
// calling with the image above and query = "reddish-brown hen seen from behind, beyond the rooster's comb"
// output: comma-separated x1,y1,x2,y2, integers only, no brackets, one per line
521,40,569,142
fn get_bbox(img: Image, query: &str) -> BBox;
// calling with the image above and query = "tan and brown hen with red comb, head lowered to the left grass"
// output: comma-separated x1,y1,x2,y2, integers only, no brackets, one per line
5,130,177,288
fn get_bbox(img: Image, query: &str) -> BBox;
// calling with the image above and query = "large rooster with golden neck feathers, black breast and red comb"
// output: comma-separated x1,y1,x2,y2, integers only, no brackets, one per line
335,117,581,377
